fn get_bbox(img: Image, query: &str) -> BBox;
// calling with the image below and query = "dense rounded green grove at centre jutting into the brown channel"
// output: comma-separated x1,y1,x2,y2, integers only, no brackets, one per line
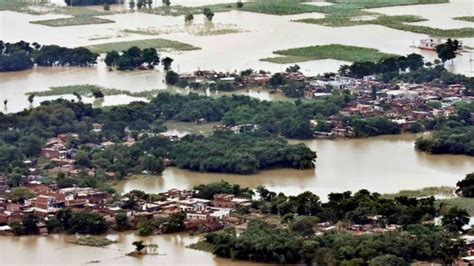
172,131,316,174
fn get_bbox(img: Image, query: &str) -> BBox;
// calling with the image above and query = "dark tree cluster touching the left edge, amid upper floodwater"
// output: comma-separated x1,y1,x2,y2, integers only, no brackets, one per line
0,41,98,72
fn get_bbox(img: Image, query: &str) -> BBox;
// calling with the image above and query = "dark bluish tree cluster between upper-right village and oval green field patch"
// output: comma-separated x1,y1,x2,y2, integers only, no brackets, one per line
339,53,424,78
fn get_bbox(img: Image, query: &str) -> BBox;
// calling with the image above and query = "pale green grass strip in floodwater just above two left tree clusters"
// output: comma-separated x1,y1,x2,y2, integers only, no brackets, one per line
87,38,200,53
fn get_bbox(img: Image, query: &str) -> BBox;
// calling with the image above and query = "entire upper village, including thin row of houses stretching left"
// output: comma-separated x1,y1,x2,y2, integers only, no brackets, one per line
171,67,474,138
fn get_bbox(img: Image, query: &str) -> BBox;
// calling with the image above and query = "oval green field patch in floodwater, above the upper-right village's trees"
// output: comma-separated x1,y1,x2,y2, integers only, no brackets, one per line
261,44,393,64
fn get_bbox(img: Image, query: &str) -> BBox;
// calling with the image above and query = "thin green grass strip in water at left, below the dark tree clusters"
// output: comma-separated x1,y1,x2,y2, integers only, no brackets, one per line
25,84,159,99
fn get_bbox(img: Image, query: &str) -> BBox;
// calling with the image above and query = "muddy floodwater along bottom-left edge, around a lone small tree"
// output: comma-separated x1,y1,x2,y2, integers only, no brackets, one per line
0,232,266,266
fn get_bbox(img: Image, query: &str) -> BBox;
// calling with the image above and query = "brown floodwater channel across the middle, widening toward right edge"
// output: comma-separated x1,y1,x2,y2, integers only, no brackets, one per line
117,134,474,199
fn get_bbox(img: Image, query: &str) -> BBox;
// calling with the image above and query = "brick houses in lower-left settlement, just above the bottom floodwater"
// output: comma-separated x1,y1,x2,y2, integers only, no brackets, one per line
0,182,251,235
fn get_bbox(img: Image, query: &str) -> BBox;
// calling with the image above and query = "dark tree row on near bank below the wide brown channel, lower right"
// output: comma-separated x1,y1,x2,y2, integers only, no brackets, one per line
254,187,436,228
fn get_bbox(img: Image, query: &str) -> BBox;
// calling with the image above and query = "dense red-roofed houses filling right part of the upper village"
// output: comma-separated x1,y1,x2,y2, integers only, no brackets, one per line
291,73,474,137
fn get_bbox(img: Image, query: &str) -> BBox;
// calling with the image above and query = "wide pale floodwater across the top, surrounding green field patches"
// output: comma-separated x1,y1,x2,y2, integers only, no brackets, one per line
0,0,474,112
